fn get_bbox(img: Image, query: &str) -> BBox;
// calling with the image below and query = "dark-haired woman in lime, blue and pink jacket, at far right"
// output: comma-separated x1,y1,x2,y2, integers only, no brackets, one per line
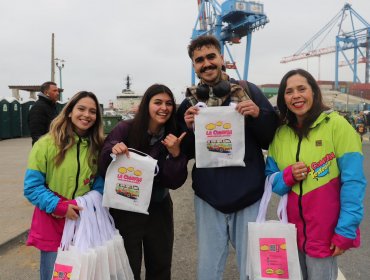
266,69,366,280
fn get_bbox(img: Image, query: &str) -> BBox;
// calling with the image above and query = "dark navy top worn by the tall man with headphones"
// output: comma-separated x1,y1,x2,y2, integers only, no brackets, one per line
177,80,278,213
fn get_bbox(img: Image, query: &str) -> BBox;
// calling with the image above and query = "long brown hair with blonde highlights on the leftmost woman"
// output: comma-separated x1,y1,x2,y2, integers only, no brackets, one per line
49,91,104,167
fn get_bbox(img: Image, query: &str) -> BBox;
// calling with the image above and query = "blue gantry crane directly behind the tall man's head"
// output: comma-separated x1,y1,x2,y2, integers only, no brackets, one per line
191,0,268,85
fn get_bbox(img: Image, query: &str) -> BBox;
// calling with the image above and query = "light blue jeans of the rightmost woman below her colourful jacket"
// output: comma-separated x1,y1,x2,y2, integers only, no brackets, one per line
298,251,338,280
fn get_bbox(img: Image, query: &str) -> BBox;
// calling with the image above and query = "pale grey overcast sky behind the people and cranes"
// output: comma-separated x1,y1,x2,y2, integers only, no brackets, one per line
0,0,370,105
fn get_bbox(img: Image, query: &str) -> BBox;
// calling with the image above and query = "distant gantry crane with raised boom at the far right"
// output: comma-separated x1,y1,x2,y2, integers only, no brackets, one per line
280,3,370,89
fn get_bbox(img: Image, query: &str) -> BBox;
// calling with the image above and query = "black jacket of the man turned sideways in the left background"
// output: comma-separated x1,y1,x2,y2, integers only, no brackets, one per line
28,96,57,146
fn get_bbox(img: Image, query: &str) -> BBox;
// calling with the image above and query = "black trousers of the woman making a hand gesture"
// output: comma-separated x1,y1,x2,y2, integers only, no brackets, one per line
110,195,174,280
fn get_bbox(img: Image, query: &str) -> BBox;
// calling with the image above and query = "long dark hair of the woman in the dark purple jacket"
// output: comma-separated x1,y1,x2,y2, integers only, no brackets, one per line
128,84,176,152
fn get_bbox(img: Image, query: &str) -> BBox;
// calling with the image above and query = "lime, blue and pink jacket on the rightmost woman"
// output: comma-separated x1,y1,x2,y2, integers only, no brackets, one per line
265,112,366,258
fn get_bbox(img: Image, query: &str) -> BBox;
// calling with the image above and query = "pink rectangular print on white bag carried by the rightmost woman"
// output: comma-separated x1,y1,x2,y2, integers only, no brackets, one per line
259,238,289,279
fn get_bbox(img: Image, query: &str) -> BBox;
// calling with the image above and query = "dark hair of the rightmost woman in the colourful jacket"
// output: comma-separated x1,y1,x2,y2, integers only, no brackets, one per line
277,69,329,137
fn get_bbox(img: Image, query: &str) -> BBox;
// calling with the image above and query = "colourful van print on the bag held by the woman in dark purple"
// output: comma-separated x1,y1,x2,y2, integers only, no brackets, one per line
116,167,143,200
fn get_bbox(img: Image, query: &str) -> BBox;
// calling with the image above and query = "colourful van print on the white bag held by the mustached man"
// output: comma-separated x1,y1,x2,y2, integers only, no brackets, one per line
206,121,233,154
